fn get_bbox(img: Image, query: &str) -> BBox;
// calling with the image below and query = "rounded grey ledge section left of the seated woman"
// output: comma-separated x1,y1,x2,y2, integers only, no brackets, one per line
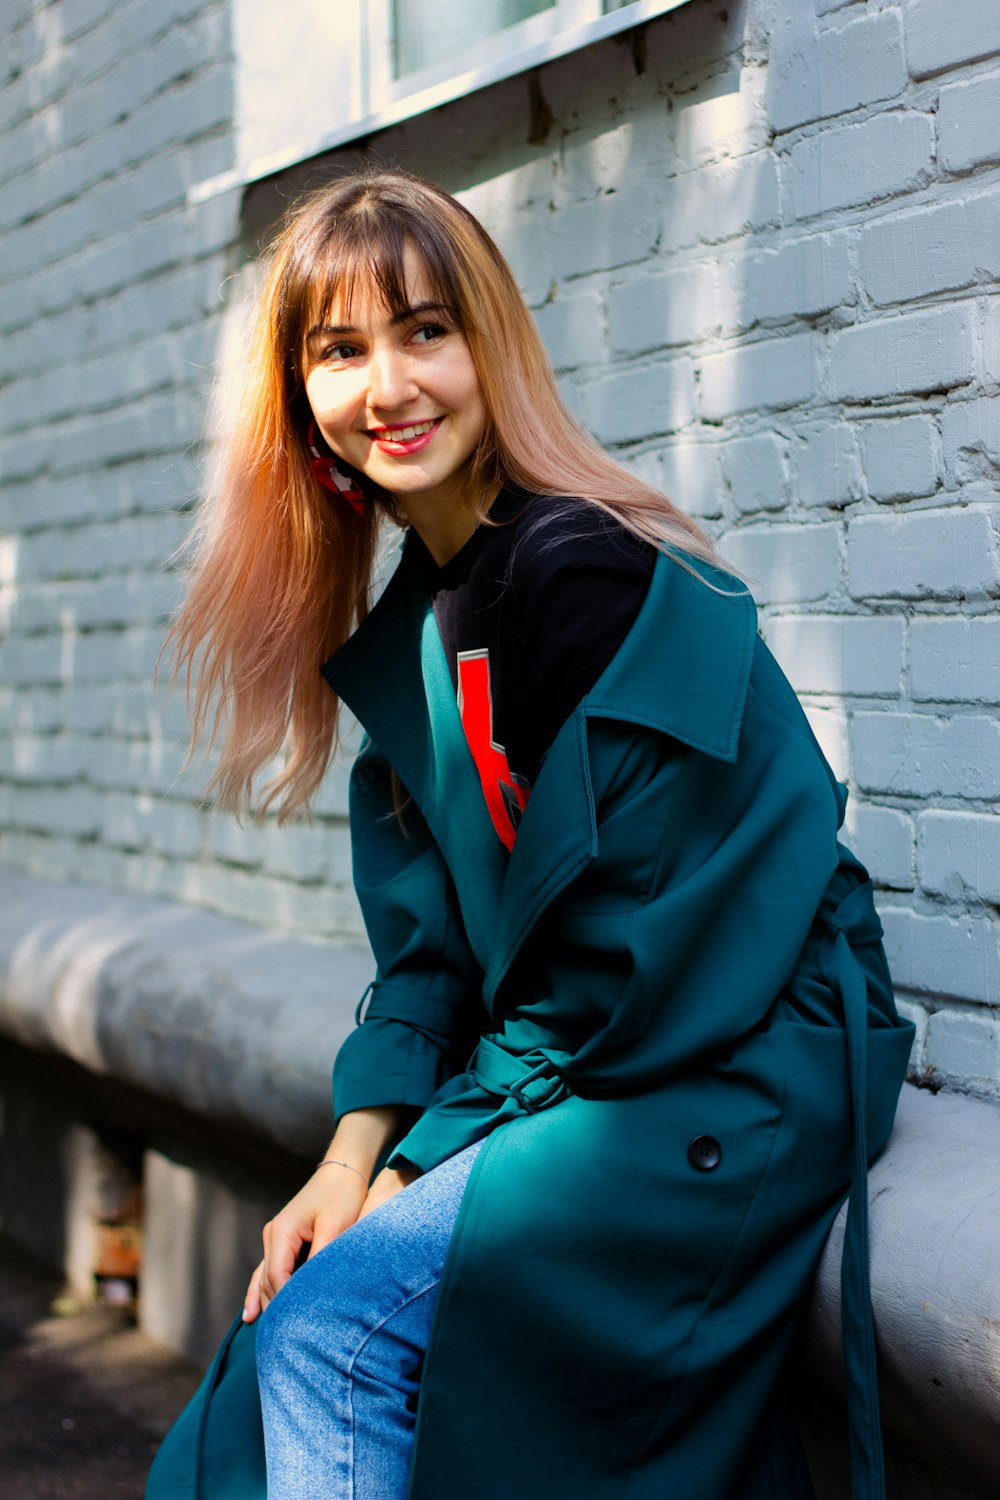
0,872,373,1157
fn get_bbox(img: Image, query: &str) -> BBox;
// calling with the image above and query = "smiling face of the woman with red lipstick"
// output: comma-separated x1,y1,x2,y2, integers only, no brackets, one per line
304,248,486,525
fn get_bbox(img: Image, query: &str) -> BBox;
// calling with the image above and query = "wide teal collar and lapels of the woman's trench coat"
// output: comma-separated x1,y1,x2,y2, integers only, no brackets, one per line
322,537,756,1004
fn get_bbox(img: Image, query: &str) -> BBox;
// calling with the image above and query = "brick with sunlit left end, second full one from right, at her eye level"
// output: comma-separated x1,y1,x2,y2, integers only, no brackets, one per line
699,333,816,422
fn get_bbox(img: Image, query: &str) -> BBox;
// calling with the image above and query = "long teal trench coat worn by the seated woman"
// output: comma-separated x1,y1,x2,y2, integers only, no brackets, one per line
147,542,913,1500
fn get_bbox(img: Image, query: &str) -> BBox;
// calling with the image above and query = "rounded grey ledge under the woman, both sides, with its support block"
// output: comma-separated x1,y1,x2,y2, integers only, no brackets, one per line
0,872,1000,1500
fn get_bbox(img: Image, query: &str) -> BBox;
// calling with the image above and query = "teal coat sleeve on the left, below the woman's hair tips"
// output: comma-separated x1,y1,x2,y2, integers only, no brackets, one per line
333,743,484,1121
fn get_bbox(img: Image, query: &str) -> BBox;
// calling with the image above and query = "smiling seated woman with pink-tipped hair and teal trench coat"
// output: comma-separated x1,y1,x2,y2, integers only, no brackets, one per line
150,173,912,1500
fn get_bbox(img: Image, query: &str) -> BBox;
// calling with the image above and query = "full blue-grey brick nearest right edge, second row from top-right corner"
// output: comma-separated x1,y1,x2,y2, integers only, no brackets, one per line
789,114,934,219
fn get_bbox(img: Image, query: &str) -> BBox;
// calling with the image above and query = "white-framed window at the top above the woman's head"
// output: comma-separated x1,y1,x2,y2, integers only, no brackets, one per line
217,0,695,198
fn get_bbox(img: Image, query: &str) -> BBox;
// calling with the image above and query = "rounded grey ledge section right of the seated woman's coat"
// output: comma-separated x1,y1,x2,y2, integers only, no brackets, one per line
805,1086,1000,1500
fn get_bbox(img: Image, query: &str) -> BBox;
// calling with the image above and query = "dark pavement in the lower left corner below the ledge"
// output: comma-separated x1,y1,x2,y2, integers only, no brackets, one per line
0,1242,201,1500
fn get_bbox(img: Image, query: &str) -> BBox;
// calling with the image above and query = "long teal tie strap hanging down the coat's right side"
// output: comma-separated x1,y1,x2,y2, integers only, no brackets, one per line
820,881,886,1500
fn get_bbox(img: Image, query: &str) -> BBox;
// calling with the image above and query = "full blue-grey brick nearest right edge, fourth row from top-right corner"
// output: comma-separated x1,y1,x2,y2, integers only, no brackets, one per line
829,306,973,401
